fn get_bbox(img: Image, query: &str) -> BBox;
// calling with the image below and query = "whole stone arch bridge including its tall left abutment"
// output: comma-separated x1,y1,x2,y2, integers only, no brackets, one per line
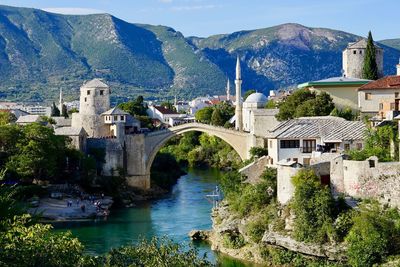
124,123,256,189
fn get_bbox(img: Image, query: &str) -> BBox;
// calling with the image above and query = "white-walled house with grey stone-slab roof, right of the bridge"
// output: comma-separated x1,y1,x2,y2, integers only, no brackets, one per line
266,116,366,166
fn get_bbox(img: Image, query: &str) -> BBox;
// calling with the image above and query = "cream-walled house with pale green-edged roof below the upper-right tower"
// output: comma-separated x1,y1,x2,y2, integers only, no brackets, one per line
297,77,370,110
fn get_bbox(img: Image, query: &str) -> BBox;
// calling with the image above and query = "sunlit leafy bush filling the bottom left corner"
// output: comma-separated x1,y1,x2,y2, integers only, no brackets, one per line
0,215,83,267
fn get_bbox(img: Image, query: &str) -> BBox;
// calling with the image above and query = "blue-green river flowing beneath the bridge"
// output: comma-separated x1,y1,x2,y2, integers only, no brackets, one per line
55,169,255,266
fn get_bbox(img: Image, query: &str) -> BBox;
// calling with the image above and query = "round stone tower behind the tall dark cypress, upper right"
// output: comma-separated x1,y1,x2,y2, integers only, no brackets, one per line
342,39,383,79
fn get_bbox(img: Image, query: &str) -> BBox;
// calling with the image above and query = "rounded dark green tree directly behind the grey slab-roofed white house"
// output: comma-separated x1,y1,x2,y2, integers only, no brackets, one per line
276,89,335,121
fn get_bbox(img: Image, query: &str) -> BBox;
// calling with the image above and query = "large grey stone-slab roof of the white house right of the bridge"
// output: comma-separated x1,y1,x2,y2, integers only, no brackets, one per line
267,116,366,142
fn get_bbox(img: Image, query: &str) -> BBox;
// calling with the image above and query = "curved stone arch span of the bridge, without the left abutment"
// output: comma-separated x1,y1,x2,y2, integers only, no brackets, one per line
145,123,253,174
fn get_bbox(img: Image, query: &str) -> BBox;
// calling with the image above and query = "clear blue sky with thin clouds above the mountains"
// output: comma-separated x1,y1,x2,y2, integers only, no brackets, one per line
0,0,400,40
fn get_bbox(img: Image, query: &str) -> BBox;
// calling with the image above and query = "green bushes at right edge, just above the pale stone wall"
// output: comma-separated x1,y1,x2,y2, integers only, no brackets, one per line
347,124,398,162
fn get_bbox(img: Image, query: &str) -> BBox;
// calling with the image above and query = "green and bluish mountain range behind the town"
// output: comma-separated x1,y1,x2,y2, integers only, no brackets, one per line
0,6,400,102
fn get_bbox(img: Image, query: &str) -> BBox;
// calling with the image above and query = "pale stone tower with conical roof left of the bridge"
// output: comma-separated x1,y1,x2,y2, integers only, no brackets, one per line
71,79,110,137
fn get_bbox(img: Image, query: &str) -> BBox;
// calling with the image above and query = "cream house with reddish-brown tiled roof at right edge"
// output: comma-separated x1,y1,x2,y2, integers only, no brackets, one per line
358,74,400,119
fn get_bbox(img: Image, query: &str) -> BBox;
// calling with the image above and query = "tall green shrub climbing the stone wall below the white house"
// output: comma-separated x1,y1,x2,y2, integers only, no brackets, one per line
291,169,335,243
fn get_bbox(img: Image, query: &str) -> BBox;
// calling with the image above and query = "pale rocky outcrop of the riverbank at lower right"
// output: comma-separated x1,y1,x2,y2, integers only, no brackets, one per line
196,203,346,265
